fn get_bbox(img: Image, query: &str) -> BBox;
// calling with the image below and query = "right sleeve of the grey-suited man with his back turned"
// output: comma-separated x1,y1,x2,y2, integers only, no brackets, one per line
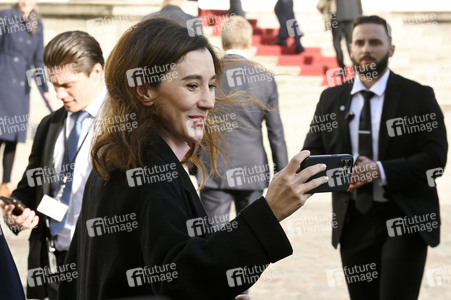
266,77,288,172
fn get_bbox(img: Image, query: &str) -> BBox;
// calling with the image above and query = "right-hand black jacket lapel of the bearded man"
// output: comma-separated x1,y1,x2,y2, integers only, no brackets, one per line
378,71,401,160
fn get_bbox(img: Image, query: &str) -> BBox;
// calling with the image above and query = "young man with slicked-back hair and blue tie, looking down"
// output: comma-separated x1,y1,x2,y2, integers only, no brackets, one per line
0,31,106,300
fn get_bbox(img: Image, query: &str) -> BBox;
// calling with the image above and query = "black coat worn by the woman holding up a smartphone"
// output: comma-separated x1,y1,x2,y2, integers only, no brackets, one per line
59,137,292,300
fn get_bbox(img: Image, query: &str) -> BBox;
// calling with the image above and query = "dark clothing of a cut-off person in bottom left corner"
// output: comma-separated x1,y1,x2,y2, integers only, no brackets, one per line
0,227,25,300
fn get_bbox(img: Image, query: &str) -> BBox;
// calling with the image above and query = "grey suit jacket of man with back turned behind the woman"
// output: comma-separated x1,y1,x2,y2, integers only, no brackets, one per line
197,55,288,190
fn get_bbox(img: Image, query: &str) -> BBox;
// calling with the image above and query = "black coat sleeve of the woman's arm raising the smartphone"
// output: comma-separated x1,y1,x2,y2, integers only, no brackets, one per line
142,193,292,300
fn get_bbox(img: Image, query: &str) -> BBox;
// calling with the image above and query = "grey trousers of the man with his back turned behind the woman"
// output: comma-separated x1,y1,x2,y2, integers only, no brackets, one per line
200,188,263,225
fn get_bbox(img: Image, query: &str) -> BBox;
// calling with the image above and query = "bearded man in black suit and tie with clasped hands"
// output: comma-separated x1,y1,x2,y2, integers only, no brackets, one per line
304,16,448,299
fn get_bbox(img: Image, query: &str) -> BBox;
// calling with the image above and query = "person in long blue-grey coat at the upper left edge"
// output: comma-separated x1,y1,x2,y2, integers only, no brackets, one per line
0,0,52,192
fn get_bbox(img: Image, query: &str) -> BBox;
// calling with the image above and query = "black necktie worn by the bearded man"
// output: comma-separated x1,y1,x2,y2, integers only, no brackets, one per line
356,91,374,214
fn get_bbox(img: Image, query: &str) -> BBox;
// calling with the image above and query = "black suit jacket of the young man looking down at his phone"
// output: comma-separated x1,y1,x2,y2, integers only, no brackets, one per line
12,107,67,298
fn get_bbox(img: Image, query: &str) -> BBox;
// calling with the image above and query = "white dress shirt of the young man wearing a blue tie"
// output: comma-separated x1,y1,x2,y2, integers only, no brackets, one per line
52,88,107,251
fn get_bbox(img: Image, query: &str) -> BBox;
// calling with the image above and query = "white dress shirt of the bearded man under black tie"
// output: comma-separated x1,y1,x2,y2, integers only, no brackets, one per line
349,70,390,202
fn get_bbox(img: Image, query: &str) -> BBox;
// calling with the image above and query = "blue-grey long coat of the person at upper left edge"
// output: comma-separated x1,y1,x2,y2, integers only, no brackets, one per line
0,7,48,142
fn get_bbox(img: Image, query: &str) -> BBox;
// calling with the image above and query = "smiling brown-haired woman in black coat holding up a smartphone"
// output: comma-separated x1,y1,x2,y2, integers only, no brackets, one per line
59,18,327,300
